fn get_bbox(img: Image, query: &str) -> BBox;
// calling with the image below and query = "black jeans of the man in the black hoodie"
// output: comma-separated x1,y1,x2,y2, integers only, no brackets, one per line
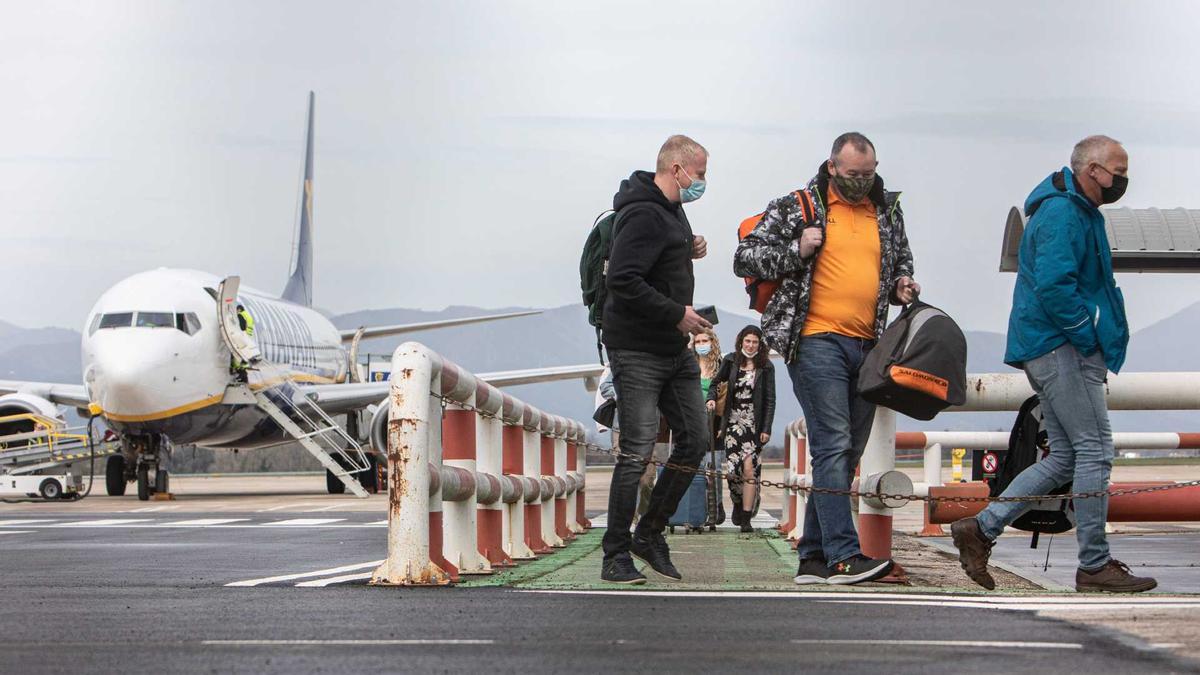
604,350,708,558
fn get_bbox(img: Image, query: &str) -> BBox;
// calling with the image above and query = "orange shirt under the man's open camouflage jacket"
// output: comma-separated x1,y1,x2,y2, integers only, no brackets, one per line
800,186,880,339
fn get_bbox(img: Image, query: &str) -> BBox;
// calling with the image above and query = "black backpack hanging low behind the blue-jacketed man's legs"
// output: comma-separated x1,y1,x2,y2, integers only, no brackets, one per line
989,396,1075,548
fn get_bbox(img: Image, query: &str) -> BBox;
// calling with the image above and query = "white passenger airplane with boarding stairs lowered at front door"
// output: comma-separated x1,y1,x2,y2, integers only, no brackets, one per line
0,92,602,500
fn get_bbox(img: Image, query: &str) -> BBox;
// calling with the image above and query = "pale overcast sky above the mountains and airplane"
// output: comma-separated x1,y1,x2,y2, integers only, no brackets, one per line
0,0,1200,330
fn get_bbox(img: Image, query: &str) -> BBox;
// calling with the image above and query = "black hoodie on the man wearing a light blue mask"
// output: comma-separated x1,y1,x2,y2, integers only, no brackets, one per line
601,171,696,356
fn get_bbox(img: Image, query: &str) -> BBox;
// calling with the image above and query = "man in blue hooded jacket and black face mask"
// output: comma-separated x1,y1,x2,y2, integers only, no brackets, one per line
950,136,1158,593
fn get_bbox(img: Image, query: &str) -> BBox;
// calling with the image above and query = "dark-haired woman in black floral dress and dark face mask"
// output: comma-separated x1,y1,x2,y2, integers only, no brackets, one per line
708,325,775,532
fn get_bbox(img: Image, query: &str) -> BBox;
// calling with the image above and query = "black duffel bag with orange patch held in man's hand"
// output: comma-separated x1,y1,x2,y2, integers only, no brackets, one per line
858,300,967,420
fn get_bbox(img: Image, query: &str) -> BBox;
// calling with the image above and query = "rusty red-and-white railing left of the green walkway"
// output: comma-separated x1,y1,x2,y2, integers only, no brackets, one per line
372,342,590,585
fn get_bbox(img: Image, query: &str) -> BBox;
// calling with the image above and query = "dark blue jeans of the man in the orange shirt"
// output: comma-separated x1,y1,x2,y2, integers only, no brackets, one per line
787,333,875,567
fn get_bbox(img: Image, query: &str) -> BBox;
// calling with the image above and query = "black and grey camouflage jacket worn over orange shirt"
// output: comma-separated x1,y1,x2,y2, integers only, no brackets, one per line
733,163,913,363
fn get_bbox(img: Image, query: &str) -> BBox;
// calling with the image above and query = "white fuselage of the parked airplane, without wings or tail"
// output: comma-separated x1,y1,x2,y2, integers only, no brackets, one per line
82,268,347,448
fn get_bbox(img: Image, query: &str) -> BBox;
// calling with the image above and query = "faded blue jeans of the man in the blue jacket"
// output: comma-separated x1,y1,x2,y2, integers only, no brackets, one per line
977,344,1114,569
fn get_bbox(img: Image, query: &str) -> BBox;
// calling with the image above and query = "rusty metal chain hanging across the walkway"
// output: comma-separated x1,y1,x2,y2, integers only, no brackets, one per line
431,393,1200,503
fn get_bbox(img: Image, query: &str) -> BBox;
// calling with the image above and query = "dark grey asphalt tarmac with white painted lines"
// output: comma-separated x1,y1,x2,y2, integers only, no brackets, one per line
0,504,1200,674
